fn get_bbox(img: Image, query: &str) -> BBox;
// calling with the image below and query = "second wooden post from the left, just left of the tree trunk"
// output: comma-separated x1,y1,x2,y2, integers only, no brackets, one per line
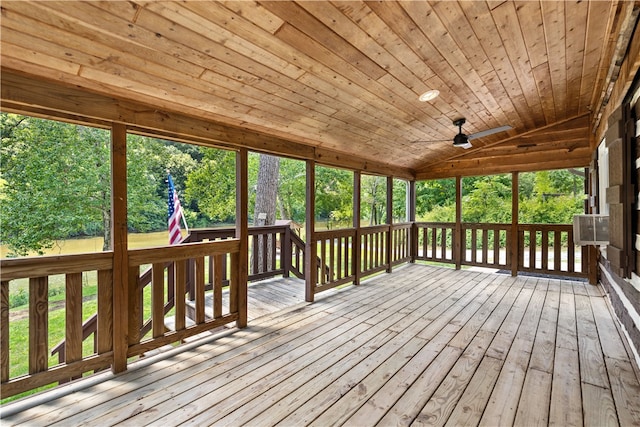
235,148,249,328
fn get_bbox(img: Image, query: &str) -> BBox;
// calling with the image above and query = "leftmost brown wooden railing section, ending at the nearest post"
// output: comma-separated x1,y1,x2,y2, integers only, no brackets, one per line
0,252,113,398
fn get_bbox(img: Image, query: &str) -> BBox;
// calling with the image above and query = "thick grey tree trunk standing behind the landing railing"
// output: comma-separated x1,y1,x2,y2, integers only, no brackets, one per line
251,154,280,273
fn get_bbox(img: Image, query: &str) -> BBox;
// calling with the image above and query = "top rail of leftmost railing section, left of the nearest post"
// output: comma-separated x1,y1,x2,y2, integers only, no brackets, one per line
0,251,113,281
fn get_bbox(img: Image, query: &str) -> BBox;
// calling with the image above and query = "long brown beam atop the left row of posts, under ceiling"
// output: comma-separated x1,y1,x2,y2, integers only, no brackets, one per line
0,68,414,180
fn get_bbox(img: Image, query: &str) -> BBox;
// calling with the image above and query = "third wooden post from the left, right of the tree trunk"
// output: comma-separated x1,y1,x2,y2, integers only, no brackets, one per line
304,160,318,302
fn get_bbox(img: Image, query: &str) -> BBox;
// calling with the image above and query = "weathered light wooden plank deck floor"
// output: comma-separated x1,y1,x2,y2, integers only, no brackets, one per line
2,265,640,426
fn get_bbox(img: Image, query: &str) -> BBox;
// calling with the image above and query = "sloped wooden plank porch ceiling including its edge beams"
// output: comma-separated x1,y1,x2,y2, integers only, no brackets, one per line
1,0,637,179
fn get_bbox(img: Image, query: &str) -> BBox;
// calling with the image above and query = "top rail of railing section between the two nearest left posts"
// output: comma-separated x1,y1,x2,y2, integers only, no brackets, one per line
129,238,240,267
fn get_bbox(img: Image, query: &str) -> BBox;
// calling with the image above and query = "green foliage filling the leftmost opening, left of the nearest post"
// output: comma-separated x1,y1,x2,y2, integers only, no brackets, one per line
0,114,110,255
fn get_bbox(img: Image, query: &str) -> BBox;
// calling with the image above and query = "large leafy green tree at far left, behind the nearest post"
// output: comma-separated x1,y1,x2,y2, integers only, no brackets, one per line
0,114,198,255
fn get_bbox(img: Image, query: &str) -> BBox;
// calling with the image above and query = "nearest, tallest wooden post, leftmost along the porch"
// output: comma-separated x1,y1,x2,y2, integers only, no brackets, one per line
110,123,127,373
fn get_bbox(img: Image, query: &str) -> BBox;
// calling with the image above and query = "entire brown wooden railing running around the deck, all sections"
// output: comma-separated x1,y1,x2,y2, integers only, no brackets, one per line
0,223,587,398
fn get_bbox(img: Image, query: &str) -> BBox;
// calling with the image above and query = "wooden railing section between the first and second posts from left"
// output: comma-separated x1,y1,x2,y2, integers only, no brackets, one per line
127,239,242,357
